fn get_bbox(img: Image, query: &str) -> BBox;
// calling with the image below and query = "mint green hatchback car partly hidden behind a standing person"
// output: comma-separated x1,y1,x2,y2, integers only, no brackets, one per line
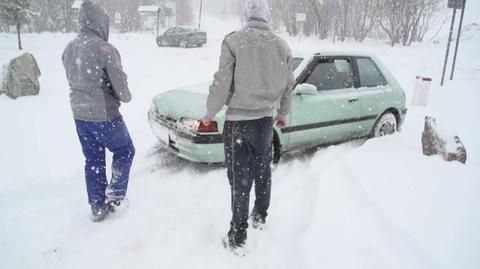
148,52,407,163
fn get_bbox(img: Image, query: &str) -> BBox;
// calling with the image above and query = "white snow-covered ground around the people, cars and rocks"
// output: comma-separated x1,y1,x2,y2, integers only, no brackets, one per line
0,18,480,269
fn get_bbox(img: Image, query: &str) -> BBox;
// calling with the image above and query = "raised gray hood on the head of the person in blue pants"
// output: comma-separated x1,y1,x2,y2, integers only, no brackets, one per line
78,0,110,41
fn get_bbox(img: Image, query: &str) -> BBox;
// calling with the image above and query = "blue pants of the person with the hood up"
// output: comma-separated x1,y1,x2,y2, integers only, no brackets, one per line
75,116,135,206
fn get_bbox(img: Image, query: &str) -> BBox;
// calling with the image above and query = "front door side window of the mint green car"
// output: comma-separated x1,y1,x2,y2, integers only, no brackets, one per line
305,58,355,91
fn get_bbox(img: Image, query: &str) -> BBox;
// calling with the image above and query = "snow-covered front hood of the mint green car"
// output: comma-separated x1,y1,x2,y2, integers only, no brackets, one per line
153,83,225,120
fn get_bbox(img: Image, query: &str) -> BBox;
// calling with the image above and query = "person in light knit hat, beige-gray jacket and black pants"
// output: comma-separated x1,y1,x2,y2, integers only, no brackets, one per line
202,0,295,254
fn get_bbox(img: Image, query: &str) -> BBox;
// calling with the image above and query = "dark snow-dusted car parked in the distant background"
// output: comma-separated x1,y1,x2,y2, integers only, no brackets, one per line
157,26,207,48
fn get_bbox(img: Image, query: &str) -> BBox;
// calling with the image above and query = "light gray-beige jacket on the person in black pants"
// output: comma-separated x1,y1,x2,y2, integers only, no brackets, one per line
207,20,295,121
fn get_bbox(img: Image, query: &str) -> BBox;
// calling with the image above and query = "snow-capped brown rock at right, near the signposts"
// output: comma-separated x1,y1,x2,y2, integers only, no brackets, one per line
422,117,467,164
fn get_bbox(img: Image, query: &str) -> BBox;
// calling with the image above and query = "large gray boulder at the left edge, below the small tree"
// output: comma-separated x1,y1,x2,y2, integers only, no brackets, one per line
0,53,41,99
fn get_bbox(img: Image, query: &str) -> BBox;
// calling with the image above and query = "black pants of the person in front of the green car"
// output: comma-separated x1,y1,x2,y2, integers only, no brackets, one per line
224,117,273,245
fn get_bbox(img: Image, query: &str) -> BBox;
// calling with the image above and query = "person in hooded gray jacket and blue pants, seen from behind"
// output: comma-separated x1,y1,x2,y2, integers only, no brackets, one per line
62,0,135,221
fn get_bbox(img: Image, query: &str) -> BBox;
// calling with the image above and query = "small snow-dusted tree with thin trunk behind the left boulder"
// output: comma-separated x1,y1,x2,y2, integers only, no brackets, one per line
0,0,31,50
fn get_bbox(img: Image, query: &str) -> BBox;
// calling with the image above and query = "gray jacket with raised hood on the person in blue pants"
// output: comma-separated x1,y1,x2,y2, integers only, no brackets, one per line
62,0,132,122
